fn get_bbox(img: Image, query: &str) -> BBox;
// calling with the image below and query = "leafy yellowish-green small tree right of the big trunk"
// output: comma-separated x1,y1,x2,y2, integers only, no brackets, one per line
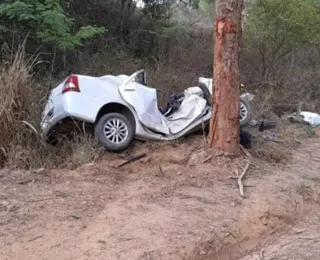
244,0,320,80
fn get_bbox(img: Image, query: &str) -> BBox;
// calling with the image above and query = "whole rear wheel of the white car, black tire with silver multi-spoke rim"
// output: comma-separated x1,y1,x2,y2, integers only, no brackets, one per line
94,113,134,152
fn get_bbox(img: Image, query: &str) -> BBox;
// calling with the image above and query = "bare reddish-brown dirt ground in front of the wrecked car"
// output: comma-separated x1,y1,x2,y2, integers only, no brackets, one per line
0,123,320,260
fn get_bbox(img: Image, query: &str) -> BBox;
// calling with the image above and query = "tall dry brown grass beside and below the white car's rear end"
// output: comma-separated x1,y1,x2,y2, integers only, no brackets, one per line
0,47,100,169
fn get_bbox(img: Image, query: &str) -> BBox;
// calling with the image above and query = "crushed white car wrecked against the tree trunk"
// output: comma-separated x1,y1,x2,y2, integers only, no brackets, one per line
41,70,251,152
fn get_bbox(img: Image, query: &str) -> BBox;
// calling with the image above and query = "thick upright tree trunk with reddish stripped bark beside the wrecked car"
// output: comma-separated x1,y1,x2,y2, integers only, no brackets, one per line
209,0,243,155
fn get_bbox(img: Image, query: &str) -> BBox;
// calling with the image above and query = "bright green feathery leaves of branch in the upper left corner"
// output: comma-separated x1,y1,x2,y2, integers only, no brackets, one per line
0,0,105,51
